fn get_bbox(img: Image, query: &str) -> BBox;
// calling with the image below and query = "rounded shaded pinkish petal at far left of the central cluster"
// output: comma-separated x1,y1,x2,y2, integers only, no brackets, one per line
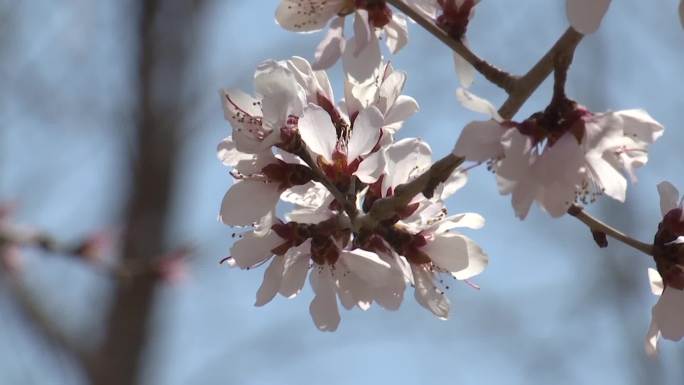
219,180,280,226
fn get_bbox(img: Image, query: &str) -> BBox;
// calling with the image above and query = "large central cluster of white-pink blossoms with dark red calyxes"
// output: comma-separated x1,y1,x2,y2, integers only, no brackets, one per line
218,57,488,331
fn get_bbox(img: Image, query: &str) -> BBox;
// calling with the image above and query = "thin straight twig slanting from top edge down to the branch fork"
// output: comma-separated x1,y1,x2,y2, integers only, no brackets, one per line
387,0,517,94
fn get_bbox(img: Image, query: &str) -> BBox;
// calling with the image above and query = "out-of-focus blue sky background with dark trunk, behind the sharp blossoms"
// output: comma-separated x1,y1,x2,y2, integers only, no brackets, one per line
0,0,684,385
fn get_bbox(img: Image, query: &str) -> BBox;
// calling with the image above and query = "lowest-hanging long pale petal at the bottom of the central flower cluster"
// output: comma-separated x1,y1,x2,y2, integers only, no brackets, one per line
309,266,340,332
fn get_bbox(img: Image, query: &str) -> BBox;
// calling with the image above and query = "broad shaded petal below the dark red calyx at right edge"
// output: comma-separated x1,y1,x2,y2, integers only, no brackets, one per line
653,287,684,341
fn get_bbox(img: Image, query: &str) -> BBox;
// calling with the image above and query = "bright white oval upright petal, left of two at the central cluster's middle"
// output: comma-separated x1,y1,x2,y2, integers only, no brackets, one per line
298,104,337,163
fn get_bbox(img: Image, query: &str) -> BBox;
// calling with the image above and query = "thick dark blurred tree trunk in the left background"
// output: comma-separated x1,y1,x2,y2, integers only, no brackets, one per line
89,0,198,385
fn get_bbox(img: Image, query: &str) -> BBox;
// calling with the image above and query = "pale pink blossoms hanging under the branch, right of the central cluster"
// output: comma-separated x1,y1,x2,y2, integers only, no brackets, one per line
454,90,663,219
